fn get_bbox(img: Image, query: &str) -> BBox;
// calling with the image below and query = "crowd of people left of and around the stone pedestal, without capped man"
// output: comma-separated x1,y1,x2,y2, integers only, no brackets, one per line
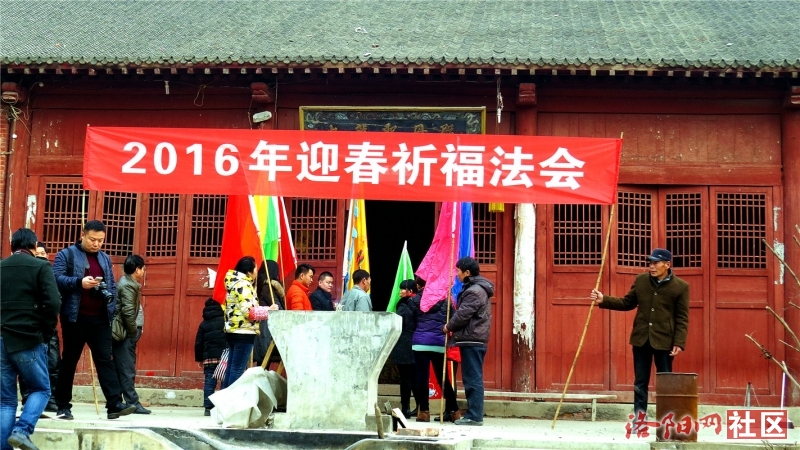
0,220,494,450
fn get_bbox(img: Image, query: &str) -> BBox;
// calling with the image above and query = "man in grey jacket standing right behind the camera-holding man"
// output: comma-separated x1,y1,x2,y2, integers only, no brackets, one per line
111,255,151,414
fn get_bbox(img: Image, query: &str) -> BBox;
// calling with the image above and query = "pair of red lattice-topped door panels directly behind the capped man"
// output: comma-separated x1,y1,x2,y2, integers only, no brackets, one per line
609,186,709,392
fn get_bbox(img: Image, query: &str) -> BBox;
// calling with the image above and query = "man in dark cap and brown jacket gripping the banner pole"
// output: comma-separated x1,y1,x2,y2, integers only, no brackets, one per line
590,248,689,418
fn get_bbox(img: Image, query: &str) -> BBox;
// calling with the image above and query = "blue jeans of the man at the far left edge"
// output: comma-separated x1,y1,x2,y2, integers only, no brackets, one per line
0,336,50,450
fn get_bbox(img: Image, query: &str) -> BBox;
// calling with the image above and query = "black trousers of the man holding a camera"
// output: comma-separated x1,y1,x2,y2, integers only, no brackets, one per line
56,314,122,409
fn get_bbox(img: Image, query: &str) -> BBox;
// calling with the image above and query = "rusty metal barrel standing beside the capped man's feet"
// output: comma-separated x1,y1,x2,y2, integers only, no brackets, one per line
656,372,697,442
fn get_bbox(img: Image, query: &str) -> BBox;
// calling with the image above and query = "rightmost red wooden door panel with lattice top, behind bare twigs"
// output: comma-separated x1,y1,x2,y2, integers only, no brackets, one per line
709,187,783,395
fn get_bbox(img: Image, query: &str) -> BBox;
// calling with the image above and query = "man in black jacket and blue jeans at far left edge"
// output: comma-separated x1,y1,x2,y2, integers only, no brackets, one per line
0,228,61,450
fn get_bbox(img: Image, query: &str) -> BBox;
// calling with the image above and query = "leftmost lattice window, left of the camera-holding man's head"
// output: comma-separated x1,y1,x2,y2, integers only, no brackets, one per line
40,183,89,251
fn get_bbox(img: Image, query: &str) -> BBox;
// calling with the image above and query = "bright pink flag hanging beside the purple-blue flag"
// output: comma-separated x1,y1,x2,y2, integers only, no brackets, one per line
416,202,461,312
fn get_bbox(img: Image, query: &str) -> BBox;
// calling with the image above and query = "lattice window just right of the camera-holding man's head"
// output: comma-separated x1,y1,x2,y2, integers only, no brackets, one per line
103,192,139,256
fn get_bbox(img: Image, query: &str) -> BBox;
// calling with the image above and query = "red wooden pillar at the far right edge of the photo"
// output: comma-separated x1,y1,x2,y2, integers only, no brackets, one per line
781,86,800,406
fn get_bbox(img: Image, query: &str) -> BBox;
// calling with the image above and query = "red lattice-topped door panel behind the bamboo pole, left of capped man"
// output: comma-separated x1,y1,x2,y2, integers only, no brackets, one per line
535,205,609,391
